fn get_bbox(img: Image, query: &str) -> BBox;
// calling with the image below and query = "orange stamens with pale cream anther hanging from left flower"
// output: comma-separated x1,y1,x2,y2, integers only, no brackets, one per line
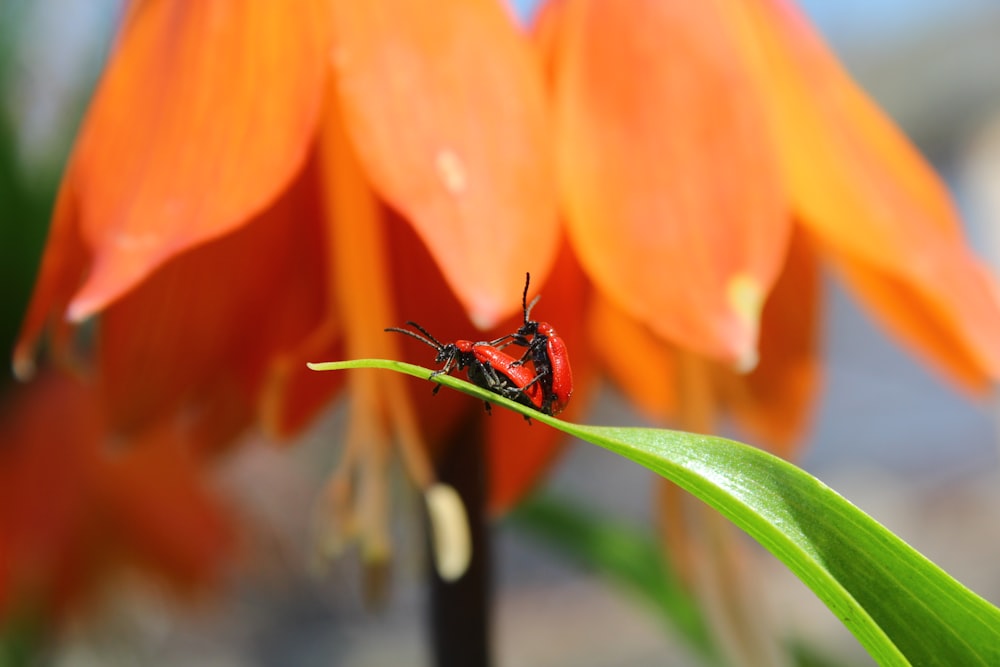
308,85,469,590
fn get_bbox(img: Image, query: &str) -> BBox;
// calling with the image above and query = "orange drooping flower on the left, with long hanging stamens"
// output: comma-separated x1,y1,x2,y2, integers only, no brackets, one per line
15,0,586,588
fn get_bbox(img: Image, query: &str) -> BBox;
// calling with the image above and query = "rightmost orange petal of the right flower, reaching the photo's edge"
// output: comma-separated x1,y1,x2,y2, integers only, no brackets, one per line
739,0,1000,386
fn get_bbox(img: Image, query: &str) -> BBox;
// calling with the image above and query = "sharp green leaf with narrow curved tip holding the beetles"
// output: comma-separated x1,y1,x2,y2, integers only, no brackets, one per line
310,359,1000,666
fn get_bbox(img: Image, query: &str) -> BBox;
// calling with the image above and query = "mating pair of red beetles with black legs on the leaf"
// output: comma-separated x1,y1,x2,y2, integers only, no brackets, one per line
386,274,573,415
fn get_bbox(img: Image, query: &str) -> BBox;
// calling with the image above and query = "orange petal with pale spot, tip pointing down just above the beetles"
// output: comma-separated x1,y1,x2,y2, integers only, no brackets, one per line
334,0,558,328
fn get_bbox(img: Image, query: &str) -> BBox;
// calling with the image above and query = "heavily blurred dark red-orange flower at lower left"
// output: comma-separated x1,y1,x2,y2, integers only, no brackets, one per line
0,375,233,619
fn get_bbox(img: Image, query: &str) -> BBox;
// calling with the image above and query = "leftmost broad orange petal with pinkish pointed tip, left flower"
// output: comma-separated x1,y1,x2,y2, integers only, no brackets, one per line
67,0,329,319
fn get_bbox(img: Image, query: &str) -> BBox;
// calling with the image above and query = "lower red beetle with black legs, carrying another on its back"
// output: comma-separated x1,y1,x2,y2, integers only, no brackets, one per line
385,322,545,412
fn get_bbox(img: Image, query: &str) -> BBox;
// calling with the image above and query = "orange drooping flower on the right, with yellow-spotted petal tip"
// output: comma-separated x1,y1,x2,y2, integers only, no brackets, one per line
538,0,1000,454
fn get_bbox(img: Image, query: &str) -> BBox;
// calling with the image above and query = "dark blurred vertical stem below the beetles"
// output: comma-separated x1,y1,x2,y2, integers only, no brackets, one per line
428,412,493,667
